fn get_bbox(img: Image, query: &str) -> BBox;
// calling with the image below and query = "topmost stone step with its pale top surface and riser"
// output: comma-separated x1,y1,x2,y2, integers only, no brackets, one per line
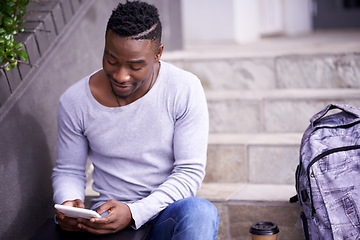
162,35,360,90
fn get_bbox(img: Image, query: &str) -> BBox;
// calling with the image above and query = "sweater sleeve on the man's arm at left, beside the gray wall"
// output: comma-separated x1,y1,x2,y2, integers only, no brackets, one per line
52,98,88,204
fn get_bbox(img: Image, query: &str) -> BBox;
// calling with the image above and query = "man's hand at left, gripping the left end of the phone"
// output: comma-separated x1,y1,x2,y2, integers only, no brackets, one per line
56,199,85,232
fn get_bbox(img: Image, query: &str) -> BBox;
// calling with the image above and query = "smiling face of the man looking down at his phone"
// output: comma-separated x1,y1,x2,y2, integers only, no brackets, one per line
103,30,158,102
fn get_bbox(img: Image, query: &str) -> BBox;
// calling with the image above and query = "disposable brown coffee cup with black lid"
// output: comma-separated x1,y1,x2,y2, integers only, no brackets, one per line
250,222,279,240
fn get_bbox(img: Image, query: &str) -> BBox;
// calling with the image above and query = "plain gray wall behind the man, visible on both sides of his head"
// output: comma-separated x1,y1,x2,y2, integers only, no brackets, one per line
0,0,182,240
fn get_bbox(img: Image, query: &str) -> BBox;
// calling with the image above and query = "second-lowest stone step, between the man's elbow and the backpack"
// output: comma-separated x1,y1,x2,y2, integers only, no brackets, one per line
204,133,302,185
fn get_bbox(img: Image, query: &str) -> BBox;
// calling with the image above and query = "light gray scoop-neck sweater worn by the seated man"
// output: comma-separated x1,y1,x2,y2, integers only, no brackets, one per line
53,62,209,229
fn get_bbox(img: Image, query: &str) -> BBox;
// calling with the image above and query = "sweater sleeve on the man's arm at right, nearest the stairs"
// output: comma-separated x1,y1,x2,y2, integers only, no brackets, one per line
128,79,209,229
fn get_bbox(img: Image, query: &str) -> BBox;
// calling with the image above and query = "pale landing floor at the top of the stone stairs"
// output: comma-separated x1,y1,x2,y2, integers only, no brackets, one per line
163,29,360,60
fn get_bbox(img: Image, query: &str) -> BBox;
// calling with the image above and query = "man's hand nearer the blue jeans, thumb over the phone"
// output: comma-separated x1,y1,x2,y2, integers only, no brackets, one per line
78,200,133,234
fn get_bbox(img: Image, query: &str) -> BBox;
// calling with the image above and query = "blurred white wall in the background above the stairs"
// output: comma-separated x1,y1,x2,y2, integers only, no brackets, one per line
182,0,312,44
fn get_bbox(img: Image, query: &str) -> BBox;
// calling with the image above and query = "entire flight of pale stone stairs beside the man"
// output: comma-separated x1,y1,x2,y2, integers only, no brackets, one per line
163,32,360,240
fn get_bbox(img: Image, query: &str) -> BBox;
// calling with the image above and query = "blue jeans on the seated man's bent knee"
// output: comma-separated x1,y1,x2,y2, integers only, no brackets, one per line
150,197,219,240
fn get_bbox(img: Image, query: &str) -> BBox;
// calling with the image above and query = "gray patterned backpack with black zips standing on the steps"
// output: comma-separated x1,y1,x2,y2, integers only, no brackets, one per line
290,104,360,240
